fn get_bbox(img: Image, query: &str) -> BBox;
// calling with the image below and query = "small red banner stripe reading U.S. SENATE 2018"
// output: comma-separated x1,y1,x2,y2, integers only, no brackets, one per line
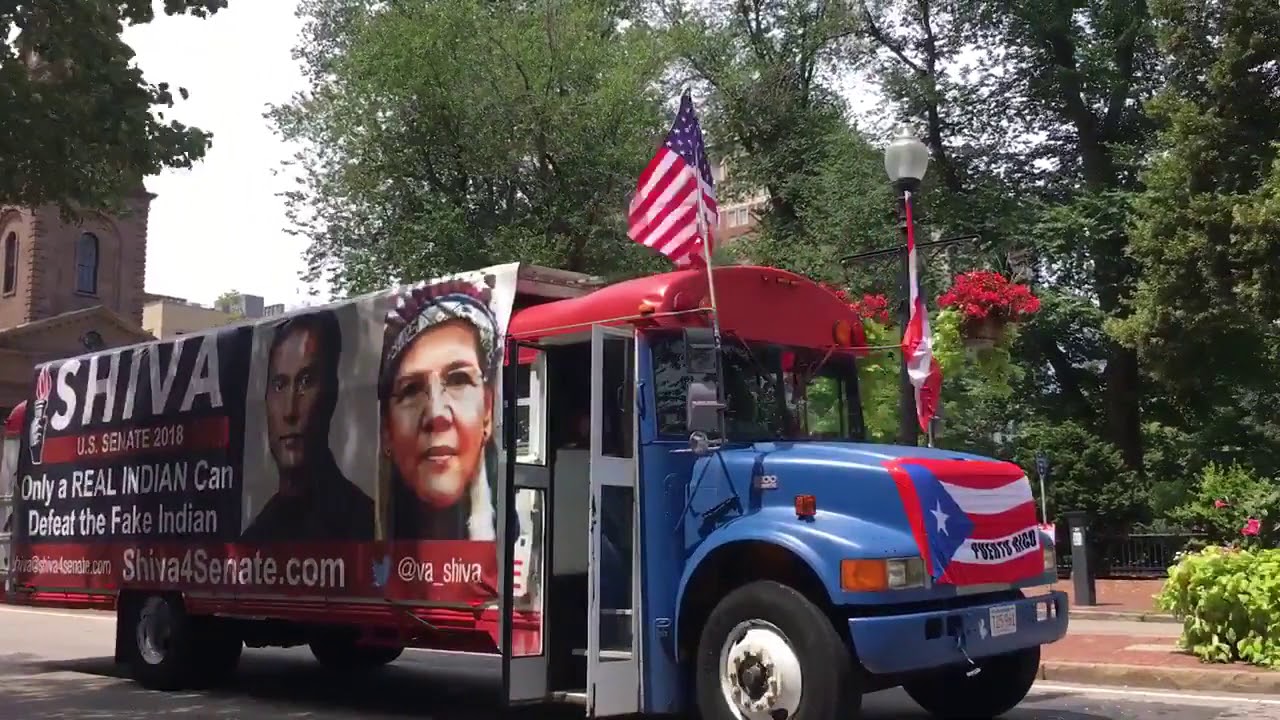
41,416,230,465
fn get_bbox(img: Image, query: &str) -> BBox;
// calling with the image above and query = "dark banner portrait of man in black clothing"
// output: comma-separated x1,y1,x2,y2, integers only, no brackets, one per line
242,310,374,542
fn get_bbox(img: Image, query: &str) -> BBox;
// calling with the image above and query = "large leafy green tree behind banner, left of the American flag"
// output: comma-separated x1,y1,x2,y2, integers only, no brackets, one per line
271,0,672,292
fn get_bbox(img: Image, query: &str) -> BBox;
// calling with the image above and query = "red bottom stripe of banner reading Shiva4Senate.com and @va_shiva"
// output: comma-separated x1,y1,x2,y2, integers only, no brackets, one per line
10,541,541,655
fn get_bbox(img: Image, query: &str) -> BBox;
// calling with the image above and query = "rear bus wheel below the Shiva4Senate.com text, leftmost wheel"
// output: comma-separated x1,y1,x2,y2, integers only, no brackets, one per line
127,594,196,691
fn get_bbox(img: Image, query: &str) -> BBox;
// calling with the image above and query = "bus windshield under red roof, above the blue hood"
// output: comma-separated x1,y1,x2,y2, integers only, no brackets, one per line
653,334,864,442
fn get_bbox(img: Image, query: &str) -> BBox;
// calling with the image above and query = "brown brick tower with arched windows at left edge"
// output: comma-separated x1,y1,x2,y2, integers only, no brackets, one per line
0,191,154,415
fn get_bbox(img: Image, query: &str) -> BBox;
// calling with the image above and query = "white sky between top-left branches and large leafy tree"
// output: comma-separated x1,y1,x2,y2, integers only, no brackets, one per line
124,0,306,306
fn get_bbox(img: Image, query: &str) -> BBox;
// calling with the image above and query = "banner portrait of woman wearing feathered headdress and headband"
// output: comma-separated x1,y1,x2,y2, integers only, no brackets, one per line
378,278,502,541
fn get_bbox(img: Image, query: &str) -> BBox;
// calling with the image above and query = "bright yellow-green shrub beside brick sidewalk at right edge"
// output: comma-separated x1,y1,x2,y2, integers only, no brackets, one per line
1156,547,1280,667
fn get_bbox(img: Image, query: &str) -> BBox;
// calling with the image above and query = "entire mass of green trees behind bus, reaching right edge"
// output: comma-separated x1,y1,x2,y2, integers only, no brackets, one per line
274,0,1280,527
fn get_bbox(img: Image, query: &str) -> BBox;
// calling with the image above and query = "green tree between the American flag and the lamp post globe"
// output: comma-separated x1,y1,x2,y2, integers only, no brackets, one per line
654,0,895,290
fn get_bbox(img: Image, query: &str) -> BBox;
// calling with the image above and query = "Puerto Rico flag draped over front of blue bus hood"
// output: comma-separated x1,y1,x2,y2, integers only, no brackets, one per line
884,457,1044,585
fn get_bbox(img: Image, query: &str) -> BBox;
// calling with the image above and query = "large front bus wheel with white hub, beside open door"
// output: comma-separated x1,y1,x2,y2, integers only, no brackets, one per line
694,580,863,720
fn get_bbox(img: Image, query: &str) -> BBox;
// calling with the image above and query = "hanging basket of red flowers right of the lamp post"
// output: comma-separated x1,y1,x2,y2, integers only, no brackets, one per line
938,270,1039,350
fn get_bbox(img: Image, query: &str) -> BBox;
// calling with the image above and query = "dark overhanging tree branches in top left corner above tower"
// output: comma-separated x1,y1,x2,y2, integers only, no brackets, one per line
0,0,227,213
